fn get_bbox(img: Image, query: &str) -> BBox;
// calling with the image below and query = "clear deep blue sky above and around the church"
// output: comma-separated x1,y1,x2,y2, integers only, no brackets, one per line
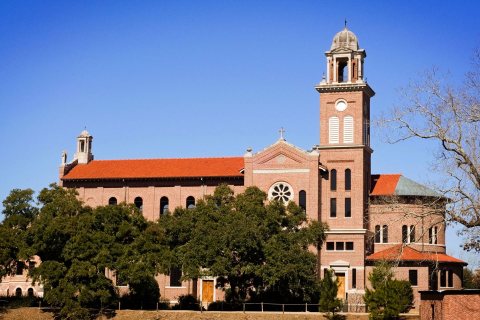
0,0,480,263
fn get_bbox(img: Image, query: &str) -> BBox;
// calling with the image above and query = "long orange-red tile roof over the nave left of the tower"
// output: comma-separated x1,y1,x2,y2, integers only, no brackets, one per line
62,157,244,180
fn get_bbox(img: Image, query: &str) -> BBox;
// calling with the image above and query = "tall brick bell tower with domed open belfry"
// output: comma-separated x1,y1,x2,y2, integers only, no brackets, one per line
315,25,375,298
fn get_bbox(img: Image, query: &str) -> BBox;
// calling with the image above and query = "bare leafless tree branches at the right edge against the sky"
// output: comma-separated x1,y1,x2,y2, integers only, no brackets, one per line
377,48,480,252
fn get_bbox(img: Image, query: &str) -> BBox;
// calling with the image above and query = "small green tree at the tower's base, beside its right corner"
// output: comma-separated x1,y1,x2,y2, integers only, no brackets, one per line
364,263,413,319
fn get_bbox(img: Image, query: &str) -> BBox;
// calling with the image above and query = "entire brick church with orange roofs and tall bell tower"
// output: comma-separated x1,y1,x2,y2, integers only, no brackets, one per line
0,27,466,307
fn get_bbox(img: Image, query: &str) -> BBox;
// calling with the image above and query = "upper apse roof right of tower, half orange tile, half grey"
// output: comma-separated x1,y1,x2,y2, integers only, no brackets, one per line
370,174,442,197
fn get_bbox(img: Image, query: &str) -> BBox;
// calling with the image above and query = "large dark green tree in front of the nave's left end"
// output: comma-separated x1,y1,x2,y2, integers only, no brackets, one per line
28,185,166,319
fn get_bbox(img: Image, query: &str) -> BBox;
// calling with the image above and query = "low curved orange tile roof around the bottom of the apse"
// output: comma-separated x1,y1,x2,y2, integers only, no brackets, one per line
367,244,467,265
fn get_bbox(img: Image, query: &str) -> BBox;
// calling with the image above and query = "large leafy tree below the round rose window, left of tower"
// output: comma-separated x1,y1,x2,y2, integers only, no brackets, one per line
159,185,326,302
